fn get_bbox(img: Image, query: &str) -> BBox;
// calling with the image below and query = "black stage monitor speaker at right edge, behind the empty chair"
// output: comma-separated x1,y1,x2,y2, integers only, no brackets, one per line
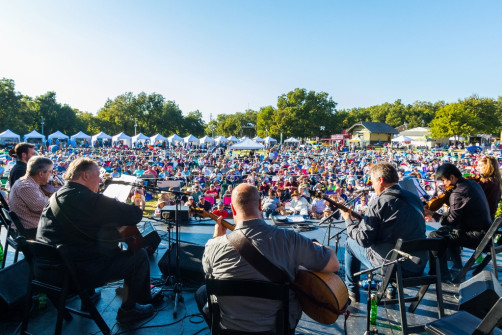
458,270,502,327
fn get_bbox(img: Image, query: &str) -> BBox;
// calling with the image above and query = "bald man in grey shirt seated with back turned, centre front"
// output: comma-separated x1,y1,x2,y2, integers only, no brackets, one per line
196,184,340,334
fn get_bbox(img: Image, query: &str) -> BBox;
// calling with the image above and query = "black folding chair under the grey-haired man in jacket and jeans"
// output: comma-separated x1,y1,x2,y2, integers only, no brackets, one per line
376,238,446,334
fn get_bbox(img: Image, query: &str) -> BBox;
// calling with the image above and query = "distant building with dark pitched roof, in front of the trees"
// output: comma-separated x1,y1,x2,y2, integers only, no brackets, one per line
347,121,399,145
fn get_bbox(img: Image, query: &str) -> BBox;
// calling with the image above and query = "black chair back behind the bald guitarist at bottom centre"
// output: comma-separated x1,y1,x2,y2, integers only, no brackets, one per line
206,279,289,335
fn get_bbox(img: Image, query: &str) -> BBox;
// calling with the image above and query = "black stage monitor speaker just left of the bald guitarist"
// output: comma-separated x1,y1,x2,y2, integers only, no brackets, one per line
158,243,205,285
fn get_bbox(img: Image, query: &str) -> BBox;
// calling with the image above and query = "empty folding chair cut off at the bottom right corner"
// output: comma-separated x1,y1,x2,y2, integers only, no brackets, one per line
425,298,502,335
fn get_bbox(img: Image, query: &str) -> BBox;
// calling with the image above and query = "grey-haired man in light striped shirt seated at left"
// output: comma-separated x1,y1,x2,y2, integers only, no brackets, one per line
9,156,52,240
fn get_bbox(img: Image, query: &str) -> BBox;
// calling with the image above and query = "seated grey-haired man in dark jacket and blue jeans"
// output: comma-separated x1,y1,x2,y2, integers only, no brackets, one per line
340,162,428,302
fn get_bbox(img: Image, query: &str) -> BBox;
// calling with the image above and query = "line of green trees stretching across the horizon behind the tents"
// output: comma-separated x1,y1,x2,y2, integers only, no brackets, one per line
0,78,502,139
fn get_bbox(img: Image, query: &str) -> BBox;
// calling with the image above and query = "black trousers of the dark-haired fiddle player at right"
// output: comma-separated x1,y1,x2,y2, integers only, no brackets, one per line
429,226,485,279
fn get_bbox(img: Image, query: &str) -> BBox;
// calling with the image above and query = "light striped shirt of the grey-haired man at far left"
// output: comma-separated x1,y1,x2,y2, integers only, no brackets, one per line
9,175,48,229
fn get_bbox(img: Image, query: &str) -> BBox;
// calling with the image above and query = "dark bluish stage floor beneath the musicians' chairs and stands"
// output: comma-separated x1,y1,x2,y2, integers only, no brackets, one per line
0,219,498,335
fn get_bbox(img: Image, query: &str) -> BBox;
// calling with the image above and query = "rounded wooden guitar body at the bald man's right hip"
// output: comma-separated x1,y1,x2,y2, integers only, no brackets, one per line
295,269,349,325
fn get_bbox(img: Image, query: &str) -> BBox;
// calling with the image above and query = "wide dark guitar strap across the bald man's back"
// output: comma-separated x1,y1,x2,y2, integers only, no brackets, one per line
227,229,345,315
